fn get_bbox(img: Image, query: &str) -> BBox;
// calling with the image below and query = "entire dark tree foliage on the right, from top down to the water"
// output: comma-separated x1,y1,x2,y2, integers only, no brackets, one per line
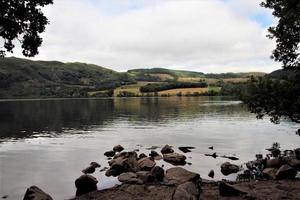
243,0,300,123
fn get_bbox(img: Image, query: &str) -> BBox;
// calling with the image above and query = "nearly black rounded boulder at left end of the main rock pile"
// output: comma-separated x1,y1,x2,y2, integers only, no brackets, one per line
75,175,98,196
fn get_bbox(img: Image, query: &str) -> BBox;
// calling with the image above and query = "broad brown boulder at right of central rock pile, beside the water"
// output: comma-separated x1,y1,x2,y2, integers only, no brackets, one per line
165,167,200,184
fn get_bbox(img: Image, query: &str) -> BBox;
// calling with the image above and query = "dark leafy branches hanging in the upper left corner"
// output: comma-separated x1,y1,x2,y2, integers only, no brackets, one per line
0,0,53,57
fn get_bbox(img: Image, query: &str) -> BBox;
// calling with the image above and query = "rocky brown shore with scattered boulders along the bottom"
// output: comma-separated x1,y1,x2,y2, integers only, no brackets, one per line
24,143,300,200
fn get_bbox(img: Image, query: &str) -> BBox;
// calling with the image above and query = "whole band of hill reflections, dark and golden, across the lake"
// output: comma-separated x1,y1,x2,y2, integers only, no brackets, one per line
0,97,250,138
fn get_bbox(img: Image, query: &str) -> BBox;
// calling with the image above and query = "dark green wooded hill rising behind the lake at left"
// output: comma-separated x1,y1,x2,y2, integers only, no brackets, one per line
0,57,135,98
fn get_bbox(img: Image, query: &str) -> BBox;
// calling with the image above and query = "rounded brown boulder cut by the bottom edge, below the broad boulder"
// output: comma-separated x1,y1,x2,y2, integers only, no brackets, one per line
173,182,200,200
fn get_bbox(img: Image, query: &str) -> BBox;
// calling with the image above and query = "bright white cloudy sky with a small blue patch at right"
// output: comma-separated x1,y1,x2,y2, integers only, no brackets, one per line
8,0,279,72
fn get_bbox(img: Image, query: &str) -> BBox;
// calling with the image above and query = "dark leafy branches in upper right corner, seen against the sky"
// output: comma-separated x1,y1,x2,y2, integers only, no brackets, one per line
261,0,300,68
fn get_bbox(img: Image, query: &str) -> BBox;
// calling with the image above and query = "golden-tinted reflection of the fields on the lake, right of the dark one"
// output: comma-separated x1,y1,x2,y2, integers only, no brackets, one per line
114,97,250,124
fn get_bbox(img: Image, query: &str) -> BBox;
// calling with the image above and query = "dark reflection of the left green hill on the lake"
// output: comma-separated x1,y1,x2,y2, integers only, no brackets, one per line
0,99,114,138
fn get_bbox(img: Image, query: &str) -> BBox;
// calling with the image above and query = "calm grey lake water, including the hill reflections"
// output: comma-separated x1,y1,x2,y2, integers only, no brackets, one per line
0,97,300,200
